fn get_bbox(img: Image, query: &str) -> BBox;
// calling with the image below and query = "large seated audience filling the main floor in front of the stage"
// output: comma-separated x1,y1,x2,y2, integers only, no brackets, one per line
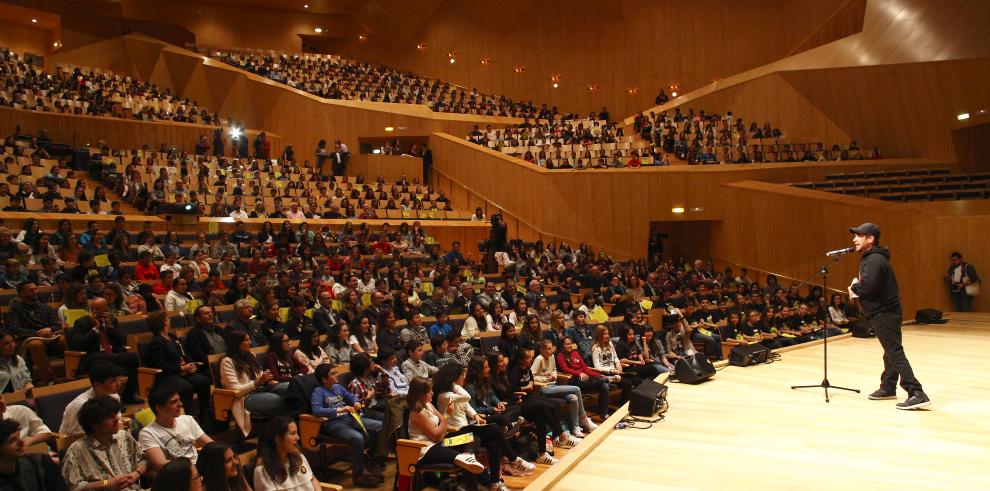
0,199,853,489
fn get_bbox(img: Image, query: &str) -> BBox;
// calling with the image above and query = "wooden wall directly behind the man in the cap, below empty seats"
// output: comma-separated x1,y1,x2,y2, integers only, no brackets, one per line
708,181,990,317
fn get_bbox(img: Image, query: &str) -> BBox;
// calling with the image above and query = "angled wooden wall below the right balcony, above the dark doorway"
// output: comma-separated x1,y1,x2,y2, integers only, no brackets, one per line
430,133,948,258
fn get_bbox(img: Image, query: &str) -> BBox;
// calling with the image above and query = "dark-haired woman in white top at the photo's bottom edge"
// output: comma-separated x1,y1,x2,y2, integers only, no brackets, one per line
254,416,320,491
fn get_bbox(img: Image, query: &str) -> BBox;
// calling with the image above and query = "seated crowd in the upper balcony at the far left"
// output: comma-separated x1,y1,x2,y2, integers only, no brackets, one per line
0,48,232,126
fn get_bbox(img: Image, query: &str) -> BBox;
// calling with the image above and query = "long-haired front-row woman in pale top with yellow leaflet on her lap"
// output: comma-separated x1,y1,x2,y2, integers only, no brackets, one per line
406,377,491,488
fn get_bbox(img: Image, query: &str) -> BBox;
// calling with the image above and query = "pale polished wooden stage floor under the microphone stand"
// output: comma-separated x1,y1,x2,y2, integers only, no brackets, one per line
548,314,990,491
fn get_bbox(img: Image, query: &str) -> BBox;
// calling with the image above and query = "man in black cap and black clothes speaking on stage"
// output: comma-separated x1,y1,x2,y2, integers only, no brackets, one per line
849,223,931,409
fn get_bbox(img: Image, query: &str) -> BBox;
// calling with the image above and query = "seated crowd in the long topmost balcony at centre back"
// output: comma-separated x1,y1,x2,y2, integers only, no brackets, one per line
210,51,557,119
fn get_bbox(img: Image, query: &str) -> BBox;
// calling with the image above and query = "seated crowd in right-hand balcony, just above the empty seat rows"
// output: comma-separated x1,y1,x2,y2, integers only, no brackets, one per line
633,107,881,164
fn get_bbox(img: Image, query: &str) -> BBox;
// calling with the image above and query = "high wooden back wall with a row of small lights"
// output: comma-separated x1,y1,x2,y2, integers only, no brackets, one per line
336,0,862,117
